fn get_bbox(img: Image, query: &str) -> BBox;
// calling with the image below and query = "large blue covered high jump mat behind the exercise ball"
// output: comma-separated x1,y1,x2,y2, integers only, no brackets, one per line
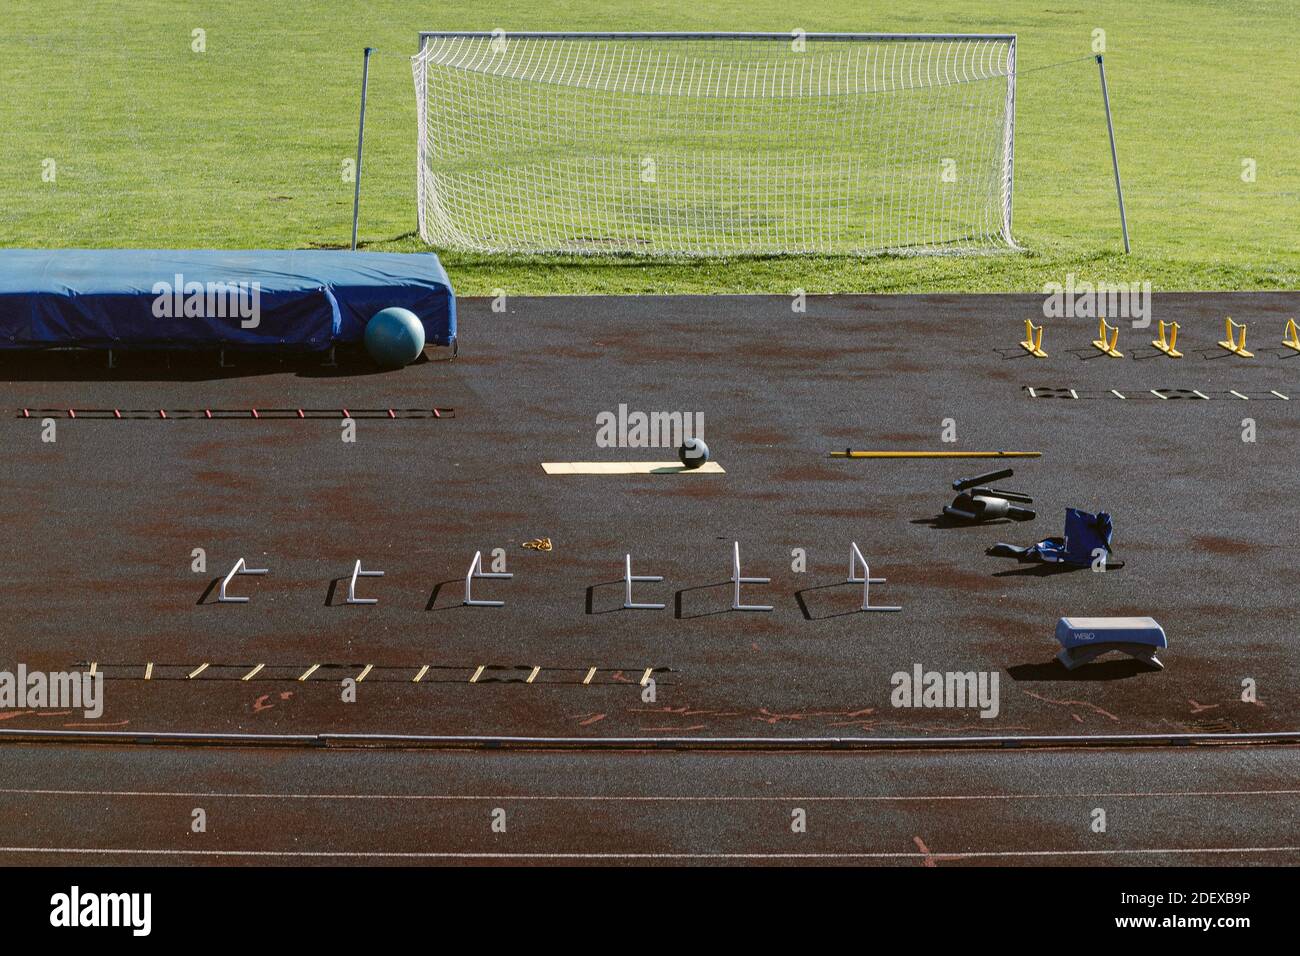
0,248,456,351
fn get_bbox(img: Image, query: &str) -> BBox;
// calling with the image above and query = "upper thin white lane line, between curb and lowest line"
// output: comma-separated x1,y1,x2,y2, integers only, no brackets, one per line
0,787,1300,803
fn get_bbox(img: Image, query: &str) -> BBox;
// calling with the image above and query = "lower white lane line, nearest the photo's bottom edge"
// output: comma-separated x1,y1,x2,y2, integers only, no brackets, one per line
0,847,1300,860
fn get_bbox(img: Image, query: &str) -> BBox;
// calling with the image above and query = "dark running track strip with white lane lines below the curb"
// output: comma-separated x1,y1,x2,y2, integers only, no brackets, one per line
0,745,1300,866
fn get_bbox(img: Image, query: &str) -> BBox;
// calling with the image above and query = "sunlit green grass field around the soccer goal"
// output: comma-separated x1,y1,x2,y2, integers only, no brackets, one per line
0,0,1300,294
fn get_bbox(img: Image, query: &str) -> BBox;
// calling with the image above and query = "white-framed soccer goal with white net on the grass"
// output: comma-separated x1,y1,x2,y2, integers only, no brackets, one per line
413,31,1015,256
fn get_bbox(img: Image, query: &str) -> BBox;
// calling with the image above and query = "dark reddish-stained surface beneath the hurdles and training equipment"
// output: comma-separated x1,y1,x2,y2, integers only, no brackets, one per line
0,294,1300,736
